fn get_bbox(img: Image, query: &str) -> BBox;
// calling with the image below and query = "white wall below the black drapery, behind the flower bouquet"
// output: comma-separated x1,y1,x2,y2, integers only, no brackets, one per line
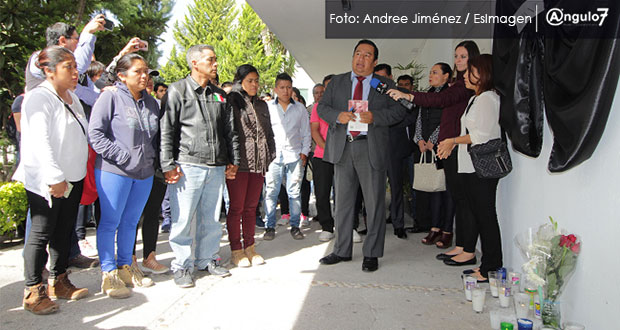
498,77,620,329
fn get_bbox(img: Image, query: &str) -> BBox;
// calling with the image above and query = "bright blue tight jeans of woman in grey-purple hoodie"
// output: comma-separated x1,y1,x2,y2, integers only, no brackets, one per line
95,169,153,272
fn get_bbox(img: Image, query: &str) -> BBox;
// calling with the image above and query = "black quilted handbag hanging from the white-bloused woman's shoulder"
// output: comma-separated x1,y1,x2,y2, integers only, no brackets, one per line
465,95,512,179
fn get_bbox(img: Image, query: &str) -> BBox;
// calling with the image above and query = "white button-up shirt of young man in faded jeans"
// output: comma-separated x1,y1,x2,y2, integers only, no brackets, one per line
268,98,312,164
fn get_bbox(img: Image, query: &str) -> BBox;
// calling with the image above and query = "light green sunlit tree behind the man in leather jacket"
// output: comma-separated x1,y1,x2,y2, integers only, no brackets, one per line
162,0,295,90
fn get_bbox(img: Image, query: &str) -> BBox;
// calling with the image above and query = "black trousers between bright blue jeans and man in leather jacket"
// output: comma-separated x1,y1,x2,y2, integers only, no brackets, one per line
133,176,168,259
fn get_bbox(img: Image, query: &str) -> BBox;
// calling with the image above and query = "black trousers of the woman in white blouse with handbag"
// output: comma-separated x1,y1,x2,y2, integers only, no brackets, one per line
459,173,502,277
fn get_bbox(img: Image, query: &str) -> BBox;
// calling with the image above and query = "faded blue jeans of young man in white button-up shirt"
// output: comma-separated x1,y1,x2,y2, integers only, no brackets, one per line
265,153,304,228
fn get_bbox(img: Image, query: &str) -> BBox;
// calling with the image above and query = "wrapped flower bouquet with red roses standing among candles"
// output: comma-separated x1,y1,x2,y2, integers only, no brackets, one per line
515,217,581,329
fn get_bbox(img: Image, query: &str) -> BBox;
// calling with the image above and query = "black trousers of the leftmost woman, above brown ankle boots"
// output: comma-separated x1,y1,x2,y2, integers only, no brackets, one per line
24,180,84,286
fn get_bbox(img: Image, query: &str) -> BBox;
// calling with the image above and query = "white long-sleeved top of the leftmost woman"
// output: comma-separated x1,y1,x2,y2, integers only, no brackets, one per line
13,80,88,207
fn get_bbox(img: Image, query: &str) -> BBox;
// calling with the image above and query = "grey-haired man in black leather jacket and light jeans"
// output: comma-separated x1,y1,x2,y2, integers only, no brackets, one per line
160,45,239,288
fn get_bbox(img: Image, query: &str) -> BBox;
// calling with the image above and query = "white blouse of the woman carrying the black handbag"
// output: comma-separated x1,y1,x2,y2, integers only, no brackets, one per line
458,91,502,173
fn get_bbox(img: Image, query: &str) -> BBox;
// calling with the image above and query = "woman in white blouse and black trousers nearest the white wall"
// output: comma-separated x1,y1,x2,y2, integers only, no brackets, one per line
438,54,502,282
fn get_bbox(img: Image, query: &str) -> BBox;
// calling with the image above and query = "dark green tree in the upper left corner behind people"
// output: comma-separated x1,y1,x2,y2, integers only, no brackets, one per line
0,0,174,174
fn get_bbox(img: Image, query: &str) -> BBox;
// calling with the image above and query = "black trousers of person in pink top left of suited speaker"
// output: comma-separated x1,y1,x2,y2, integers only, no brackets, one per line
310,157,334,233
